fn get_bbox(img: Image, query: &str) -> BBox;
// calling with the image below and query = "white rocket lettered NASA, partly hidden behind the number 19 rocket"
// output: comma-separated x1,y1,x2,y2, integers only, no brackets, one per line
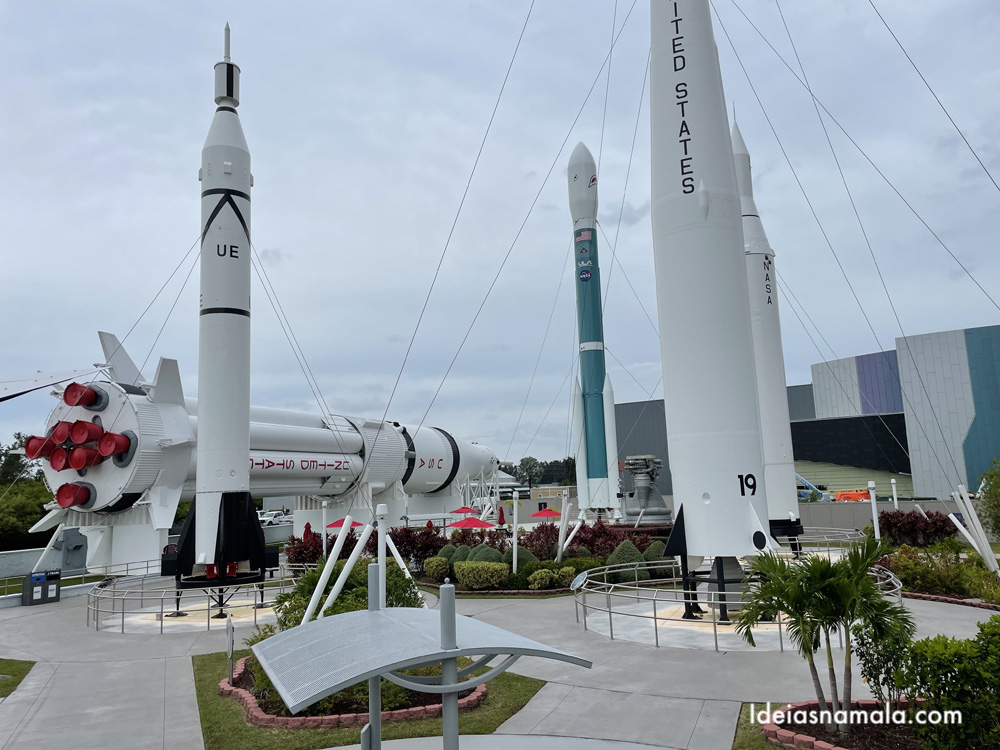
733,123,802,536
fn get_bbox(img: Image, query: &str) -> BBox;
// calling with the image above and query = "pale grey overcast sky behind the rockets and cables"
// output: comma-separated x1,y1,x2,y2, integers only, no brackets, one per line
0,0,1000,468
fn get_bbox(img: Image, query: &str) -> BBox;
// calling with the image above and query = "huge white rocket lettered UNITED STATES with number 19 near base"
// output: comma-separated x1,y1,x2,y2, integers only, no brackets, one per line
650,0,768,557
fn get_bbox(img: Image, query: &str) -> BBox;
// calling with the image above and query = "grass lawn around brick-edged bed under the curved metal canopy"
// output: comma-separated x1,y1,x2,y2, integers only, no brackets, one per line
193,650,545,750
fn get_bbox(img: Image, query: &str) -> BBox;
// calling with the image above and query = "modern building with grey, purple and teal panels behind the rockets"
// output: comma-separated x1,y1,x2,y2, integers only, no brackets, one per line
615,326,1000,499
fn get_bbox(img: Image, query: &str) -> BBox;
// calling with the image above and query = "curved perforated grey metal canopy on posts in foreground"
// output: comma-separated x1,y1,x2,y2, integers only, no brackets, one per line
252,607,591,714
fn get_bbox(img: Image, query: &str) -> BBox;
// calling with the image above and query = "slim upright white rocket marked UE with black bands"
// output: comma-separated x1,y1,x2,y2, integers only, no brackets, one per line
194,24,253,577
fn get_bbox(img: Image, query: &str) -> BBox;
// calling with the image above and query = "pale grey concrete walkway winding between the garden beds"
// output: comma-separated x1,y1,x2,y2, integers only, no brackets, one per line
0,597,990,750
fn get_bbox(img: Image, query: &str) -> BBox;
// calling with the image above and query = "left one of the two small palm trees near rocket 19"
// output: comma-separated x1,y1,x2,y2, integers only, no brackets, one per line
735,552,833,731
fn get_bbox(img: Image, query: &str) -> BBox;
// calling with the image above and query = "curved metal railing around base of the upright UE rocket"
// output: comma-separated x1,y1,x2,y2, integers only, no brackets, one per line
87,567,295,633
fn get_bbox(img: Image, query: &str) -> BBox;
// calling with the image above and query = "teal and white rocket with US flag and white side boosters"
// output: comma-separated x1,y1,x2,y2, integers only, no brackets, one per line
567,143,620,510
